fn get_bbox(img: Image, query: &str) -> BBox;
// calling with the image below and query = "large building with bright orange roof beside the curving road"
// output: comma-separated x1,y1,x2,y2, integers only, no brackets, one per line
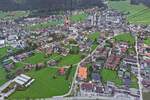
78,67,87,80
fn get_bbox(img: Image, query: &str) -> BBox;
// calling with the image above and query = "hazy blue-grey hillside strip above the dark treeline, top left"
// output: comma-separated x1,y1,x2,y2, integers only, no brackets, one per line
0,0,102,10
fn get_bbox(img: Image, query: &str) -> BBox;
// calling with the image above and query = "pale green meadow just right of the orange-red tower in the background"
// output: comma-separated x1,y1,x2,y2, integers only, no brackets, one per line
70,13,87,22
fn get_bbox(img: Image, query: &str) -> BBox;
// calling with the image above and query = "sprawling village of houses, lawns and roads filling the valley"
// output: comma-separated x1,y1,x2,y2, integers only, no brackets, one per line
0,0,150,100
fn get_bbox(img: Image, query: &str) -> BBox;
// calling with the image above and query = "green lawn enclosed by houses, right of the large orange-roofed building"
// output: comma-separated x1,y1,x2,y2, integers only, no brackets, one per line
100,69,123,86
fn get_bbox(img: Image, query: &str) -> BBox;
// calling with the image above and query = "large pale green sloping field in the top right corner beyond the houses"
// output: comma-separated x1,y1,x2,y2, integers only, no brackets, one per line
109,0,150,24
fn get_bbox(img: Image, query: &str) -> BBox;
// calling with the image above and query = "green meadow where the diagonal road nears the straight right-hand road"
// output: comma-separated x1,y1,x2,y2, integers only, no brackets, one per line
114,33,135,45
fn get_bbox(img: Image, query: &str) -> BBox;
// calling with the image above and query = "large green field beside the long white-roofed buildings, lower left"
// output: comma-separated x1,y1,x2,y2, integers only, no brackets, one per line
9,68,70,100
